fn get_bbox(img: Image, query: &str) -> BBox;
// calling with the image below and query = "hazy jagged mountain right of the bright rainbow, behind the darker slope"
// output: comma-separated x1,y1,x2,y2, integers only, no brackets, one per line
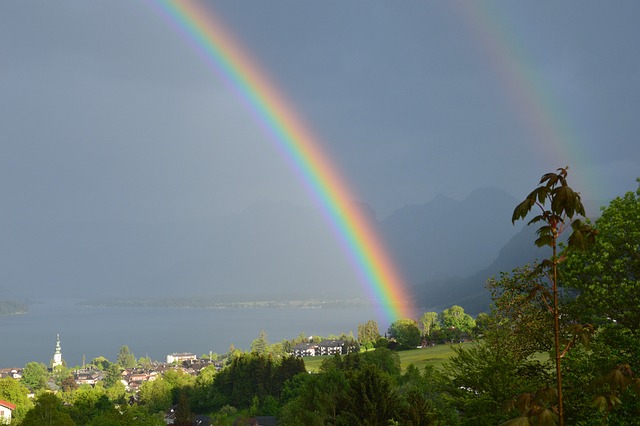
380,188,522,285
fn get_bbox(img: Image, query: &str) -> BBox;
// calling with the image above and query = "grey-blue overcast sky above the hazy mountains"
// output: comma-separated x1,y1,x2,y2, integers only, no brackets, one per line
0,0,640,222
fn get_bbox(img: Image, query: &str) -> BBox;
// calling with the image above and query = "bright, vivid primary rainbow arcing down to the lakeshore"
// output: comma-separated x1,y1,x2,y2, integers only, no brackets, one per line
149,0,413,322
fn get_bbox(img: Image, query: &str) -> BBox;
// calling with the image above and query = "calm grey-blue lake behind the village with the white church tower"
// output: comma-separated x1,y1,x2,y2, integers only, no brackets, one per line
0,300,388,368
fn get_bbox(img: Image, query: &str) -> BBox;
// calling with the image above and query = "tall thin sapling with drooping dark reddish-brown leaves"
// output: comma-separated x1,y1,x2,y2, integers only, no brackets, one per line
511,167,595,426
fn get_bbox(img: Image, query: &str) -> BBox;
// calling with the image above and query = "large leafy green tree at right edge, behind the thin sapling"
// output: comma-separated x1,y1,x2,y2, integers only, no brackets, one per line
561,179,640,424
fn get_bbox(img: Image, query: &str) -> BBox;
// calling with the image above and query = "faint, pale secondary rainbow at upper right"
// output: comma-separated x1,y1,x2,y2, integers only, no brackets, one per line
449,1,604,193
